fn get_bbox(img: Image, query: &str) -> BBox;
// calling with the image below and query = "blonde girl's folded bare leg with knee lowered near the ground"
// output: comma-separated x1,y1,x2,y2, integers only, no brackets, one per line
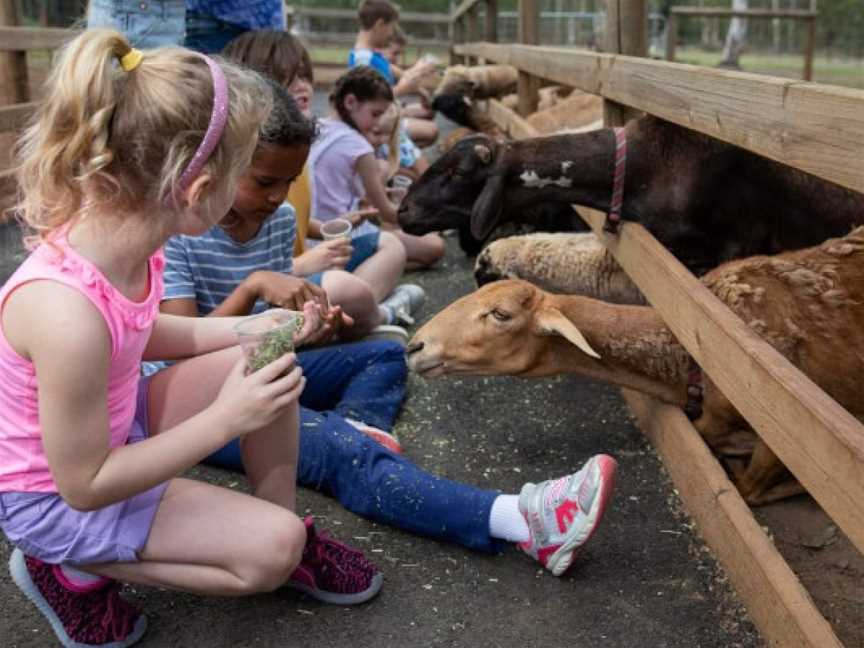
86,479,306,596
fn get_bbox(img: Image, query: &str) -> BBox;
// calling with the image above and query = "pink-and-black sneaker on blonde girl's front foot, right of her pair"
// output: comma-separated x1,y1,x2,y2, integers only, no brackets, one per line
286,517,384,605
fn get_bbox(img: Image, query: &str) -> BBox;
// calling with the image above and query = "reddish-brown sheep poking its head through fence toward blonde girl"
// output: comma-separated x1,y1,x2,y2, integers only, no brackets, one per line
408,227,864,505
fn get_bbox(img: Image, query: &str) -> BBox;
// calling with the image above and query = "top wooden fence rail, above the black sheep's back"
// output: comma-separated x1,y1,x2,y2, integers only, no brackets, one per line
456,43,864,192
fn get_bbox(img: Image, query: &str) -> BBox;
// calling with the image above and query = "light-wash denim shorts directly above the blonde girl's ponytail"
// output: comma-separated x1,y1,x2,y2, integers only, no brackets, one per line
87,0,186,49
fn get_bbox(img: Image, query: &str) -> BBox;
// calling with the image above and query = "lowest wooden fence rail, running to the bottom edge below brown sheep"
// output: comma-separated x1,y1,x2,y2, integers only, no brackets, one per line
622,389,842,648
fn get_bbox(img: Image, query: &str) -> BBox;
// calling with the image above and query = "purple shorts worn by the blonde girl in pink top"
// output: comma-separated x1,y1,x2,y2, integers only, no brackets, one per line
0,378,168,565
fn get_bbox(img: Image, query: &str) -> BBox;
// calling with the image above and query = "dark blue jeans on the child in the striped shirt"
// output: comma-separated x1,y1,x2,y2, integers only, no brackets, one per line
208,342,506,553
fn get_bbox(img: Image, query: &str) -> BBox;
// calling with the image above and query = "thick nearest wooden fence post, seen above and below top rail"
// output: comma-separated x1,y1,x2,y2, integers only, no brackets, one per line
603,0,648,126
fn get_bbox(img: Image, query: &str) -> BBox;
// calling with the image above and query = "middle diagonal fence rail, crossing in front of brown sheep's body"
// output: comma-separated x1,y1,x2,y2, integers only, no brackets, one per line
579,208,864,551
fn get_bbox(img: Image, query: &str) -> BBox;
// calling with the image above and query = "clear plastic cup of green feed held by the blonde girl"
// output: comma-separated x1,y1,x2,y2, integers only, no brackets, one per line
234,310,303,372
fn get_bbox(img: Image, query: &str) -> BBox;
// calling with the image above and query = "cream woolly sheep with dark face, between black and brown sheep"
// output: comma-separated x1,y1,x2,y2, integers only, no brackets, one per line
474,232,645,304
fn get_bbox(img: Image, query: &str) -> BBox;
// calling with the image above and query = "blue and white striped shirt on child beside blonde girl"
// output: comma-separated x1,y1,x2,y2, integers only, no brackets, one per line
164,203,297,315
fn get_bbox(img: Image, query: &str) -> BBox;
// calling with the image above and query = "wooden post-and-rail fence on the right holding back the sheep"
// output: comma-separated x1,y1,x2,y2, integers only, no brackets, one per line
452,0,864,648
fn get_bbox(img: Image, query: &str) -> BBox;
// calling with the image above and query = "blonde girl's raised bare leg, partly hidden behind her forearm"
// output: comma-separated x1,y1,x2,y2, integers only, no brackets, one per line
148,347,299,510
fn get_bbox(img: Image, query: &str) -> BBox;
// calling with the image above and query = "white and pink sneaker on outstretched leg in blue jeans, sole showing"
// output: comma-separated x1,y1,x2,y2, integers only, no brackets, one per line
519,454,617,576
